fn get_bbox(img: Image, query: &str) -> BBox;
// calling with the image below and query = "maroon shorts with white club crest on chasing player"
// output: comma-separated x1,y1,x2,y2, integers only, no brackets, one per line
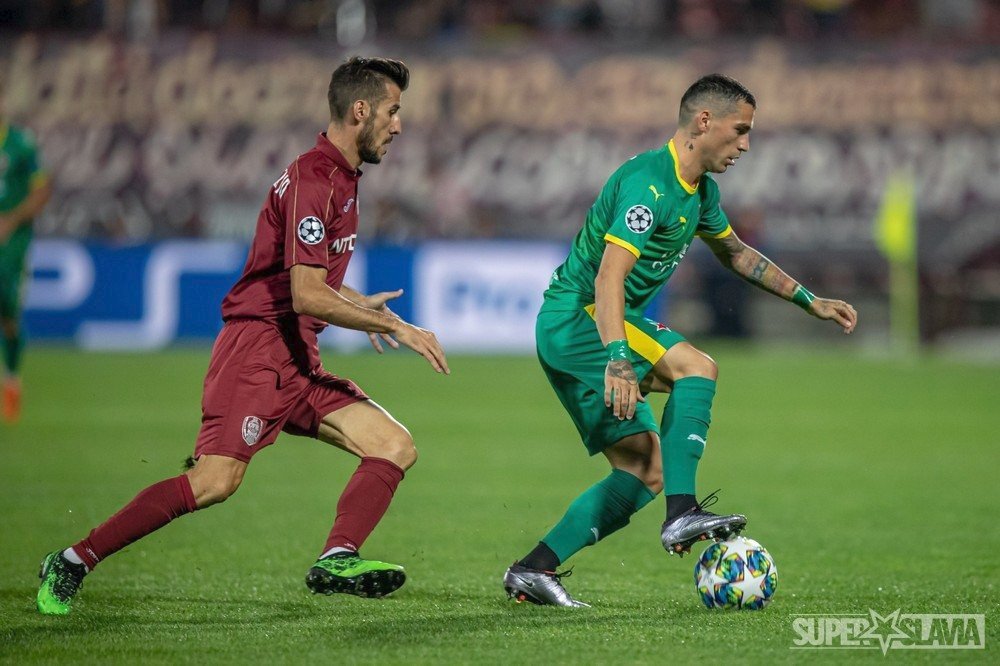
194,320,368,462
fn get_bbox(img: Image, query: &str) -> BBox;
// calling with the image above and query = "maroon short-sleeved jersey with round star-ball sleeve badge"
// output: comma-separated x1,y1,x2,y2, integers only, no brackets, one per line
222,133,361,373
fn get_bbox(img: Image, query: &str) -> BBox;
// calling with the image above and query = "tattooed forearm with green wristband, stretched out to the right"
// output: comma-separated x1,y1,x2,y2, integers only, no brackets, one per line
703,232,858,333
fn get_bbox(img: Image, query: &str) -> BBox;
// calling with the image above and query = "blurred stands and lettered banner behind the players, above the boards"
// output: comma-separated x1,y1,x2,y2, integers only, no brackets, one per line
0,0,1000,338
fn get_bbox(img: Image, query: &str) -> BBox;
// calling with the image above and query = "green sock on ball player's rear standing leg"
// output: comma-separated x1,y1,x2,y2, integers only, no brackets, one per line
542,469,656,562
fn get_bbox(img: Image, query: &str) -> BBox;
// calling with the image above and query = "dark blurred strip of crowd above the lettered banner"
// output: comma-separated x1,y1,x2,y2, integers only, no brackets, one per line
0,0,1000,42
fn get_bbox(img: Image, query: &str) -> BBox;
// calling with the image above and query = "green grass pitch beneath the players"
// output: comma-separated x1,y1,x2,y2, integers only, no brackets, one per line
0,346,1000,664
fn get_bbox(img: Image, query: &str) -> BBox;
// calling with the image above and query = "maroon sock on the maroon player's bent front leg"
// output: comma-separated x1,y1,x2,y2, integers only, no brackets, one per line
323,458,403,553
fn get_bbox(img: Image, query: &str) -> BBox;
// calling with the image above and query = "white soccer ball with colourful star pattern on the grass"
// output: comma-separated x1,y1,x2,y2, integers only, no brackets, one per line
694,537,778,610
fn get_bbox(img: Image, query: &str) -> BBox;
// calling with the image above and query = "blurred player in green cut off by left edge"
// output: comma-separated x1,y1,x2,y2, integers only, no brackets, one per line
0,81,52,422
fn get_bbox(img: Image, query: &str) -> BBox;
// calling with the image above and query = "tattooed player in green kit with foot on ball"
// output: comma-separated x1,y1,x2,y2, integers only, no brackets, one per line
503,74,857,606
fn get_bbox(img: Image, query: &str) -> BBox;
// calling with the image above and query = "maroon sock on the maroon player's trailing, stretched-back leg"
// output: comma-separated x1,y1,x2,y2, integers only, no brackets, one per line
73,474,198,571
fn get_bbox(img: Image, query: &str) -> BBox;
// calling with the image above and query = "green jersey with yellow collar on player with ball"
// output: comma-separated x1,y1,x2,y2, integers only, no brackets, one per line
542,141,732,315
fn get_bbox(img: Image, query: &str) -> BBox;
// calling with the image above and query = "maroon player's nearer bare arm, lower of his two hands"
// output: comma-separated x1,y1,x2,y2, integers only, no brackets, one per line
290,264,451,375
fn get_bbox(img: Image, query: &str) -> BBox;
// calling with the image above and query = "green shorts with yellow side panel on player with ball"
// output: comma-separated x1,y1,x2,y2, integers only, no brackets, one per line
535,305,684,455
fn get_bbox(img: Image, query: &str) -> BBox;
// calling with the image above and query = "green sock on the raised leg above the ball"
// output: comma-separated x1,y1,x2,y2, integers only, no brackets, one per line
660,377,715,495
